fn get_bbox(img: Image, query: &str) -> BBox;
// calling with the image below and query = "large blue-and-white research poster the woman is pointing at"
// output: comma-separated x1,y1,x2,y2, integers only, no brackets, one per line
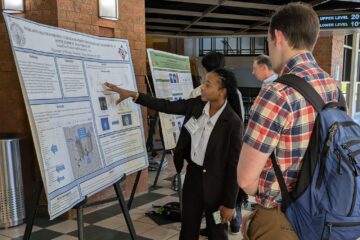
4,14,148,219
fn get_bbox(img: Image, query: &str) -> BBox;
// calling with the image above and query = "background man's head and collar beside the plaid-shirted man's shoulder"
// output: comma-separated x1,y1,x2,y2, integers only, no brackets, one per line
252,55,278,88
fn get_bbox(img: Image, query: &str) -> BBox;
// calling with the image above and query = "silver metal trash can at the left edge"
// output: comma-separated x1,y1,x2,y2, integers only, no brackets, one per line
0,133,25,228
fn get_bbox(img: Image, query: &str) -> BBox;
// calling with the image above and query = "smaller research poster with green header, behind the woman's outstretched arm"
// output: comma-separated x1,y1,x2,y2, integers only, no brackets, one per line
147,49,193,149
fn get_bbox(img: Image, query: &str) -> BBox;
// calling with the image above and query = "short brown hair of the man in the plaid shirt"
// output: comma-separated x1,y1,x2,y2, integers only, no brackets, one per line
269,3,320,51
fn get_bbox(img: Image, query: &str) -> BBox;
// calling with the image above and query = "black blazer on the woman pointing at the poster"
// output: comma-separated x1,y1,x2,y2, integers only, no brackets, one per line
136,93,243,208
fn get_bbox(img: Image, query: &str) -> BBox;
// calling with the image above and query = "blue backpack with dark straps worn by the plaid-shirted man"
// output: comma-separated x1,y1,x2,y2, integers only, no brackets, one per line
271,75,360,240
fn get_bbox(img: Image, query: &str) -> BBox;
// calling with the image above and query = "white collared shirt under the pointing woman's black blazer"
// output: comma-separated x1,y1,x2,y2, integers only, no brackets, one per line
191,101,227,166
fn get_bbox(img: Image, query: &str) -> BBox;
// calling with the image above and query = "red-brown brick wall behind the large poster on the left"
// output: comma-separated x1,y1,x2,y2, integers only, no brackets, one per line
0,0,148,218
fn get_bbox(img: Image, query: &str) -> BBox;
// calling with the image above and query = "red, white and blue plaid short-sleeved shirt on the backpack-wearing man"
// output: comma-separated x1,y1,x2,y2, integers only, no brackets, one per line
244,52,337,208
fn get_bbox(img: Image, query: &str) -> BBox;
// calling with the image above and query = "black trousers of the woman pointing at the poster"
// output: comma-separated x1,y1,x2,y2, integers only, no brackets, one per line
179,163,228,240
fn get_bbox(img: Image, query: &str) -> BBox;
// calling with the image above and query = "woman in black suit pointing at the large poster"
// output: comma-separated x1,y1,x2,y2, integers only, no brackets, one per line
105,68,243,240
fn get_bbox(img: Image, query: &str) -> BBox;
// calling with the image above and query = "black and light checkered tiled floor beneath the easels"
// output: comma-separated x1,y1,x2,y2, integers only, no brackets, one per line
0,153,247,240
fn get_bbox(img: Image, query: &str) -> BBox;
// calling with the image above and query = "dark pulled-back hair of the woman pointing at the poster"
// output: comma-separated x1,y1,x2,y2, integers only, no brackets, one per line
211,68,242,119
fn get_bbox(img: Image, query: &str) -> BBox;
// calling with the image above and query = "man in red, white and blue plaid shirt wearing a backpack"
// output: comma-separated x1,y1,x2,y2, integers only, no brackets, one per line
238,3,337,240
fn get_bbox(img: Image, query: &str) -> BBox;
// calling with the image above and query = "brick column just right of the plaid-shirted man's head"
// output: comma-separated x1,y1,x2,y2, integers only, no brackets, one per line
313,32,344,83
